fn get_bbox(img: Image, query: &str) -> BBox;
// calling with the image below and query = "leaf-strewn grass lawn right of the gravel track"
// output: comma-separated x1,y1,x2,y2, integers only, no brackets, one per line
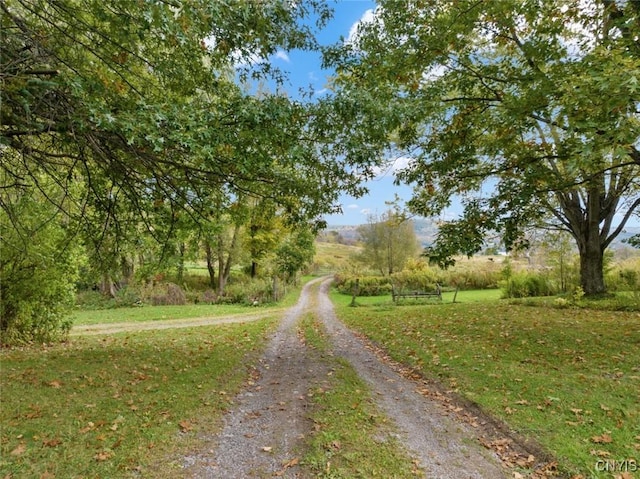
332,293,640,479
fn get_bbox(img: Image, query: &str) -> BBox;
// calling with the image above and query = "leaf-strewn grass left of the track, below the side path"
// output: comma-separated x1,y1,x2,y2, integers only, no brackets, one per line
0,320,275,478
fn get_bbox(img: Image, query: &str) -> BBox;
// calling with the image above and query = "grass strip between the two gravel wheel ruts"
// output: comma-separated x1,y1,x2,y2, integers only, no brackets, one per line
301,316,422,479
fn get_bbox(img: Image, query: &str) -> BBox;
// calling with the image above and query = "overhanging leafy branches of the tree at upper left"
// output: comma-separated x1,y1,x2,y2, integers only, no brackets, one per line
0,0,372,251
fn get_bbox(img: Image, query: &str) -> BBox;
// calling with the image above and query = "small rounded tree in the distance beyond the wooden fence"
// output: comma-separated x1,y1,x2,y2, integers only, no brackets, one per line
358,209,419,275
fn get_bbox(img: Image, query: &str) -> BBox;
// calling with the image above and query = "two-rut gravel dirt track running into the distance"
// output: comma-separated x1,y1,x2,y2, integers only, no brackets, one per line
184,280,507,479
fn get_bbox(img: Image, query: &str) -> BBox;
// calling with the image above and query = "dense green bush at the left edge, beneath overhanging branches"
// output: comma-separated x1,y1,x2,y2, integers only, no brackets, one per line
0,187,81,344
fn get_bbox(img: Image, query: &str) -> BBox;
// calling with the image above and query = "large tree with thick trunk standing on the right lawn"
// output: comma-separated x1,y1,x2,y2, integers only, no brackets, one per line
326,0,640,295
